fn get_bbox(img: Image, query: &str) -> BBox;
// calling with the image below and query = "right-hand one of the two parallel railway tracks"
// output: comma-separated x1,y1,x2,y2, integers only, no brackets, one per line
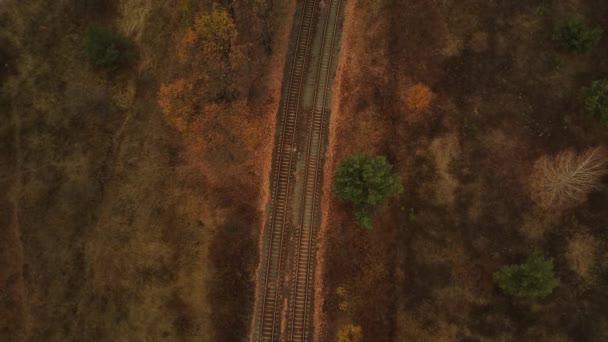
287,0,341,341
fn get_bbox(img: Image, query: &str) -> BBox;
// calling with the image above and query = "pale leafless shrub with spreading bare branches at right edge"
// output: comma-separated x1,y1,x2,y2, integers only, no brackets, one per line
531,147,608,209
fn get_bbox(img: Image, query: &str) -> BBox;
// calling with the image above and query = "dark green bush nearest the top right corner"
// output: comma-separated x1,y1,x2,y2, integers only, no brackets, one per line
553,20,602,54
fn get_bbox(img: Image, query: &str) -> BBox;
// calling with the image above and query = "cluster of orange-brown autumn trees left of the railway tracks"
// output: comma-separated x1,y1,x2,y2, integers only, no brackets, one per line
158,6,268,190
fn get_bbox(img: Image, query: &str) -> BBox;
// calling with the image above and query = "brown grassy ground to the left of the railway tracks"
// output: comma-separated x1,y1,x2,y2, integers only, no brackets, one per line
0,0,292,341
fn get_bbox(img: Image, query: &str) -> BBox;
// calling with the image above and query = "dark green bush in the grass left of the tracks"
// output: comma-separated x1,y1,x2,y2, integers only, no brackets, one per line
84,24,129,66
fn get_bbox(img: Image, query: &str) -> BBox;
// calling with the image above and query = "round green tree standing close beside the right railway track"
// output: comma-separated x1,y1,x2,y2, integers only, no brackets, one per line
332,152,403,228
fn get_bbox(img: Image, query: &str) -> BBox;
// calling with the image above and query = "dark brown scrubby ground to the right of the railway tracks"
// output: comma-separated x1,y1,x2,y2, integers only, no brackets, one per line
319,0,608,341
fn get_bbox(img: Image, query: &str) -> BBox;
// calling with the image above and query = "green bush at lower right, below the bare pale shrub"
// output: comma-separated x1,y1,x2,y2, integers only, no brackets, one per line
494,252,559,297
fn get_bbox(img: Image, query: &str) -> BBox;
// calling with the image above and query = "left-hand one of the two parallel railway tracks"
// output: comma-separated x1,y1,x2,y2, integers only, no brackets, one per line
254,0,317,341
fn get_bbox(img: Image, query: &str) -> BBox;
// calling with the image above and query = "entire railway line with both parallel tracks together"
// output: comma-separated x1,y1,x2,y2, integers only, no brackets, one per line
252,0,342,341
